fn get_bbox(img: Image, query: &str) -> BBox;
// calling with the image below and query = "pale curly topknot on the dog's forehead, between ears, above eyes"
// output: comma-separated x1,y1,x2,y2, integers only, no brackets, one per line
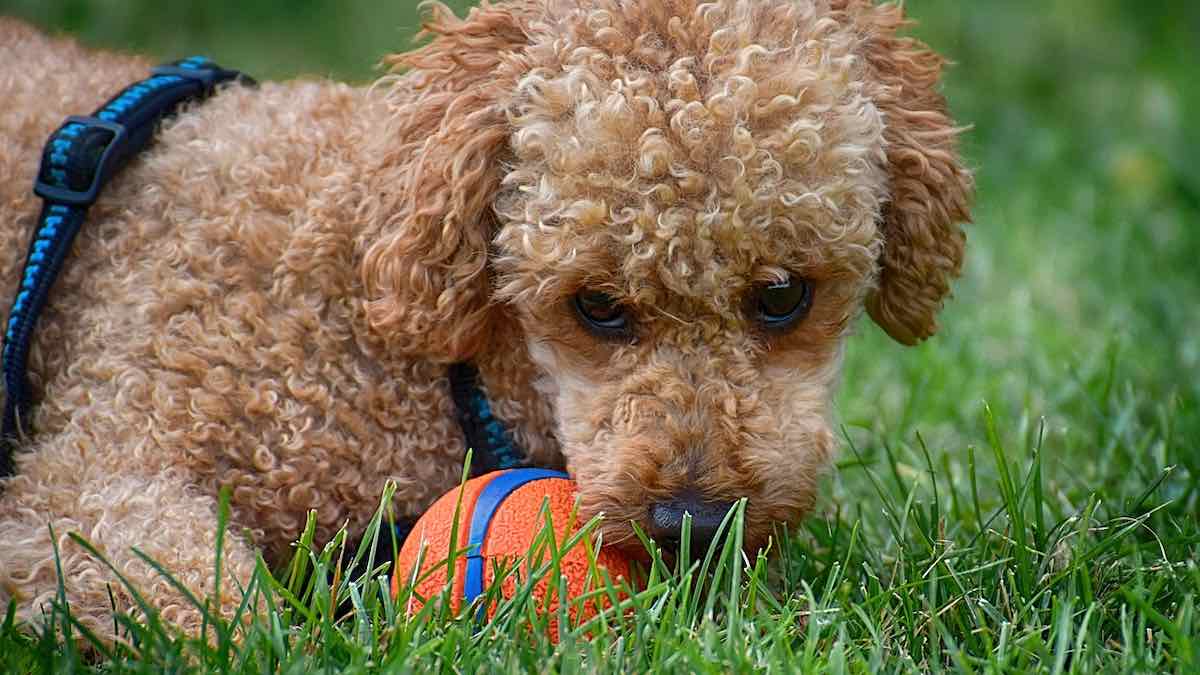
487,2,886,311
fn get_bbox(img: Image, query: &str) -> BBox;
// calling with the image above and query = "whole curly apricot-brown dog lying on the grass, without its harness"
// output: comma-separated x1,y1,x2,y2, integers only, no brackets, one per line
0,0,972,637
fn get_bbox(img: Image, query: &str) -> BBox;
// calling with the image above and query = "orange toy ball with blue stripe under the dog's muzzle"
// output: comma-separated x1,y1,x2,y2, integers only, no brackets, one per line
391,468,630,635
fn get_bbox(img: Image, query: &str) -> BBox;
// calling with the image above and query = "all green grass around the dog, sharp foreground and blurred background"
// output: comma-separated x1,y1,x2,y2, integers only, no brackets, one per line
0,0,1200,673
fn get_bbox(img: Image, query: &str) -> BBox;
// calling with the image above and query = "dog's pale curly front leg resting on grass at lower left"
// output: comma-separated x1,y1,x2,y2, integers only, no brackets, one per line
0,440,254,640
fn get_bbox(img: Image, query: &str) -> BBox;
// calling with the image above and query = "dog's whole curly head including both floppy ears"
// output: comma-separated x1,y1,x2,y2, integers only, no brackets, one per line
364,0,971,545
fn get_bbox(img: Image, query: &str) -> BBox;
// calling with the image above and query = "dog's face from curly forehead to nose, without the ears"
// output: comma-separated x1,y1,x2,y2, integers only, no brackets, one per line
493,4,887,550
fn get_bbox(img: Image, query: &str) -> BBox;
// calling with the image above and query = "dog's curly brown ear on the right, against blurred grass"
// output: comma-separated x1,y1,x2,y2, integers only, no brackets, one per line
835,0,974,345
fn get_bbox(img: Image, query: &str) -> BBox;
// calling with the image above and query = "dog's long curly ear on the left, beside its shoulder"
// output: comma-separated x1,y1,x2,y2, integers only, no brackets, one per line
361,1,528,362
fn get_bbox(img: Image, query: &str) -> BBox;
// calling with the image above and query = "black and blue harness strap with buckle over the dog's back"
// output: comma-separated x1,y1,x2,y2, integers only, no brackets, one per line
0,56,254,478
